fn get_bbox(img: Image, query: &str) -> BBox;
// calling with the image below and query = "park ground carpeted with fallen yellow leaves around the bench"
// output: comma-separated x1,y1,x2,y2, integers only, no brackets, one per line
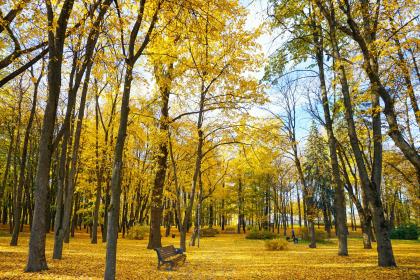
0,230,420,280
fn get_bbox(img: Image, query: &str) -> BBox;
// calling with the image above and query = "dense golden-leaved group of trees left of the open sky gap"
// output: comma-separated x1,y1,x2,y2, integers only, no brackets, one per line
1,0,265,279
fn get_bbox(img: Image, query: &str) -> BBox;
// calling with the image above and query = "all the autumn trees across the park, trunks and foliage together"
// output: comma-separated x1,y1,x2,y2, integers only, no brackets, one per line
0,0,419,279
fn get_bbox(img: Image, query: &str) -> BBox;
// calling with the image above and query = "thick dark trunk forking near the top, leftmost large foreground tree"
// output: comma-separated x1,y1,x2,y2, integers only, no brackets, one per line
26,0,74,272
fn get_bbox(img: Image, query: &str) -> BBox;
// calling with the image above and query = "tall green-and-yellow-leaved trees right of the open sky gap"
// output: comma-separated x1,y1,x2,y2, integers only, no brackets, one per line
266,0,420,266
